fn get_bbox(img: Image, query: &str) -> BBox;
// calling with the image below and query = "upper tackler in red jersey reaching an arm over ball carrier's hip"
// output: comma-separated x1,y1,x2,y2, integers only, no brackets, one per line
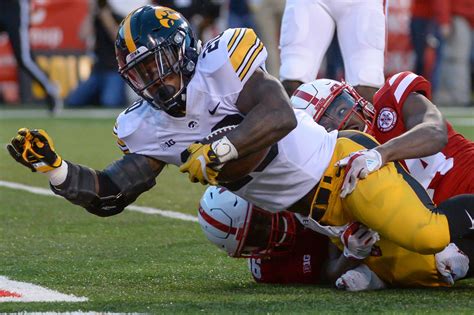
292,71,474,204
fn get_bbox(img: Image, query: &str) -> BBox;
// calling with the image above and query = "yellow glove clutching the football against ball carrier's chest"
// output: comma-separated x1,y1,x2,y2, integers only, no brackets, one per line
179,143,221,185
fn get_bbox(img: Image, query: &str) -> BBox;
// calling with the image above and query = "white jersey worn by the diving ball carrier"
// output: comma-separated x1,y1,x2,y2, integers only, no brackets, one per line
114,28,337,211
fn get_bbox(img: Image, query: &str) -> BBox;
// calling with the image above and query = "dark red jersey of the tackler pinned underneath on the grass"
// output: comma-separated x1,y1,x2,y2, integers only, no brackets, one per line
249,222,329,284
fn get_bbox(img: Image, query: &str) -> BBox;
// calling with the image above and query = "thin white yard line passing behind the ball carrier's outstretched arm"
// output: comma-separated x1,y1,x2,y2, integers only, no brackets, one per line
0,180,198,222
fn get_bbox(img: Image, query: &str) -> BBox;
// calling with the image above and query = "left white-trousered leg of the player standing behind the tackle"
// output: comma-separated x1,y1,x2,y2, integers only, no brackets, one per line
280,0,335,95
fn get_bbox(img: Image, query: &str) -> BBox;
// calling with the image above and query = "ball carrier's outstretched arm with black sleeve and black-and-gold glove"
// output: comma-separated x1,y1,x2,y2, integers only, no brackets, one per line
7,128,165,217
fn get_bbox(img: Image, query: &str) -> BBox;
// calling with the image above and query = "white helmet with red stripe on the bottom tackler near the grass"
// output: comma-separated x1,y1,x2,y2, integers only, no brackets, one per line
198,186,296,257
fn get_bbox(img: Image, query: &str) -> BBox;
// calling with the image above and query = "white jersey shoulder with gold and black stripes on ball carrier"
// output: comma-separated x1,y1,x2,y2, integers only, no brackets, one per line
197,28,267,93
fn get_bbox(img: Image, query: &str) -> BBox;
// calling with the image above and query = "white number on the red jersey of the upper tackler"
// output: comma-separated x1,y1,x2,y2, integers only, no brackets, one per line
405,152,454,198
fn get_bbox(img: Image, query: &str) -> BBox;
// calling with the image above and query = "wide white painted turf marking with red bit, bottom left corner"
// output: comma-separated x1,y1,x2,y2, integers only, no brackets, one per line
0,276,88,303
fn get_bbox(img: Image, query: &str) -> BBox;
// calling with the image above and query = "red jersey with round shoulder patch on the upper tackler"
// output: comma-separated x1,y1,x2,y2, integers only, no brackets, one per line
374,71,474,204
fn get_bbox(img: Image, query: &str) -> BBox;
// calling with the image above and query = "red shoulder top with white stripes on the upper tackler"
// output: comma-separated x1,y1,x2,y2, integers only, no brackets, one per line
374,71,431,104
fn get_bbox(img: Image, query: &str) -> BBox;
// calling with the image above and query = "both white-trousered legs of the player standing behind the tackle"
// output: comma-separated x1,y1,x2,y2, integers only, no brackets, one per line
280,0,386,100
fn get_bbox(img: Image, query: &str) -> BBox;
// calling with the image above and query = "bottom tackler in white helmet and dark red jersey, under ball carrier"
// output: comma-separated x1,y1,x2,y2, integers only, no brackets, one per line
198,186,376,284
